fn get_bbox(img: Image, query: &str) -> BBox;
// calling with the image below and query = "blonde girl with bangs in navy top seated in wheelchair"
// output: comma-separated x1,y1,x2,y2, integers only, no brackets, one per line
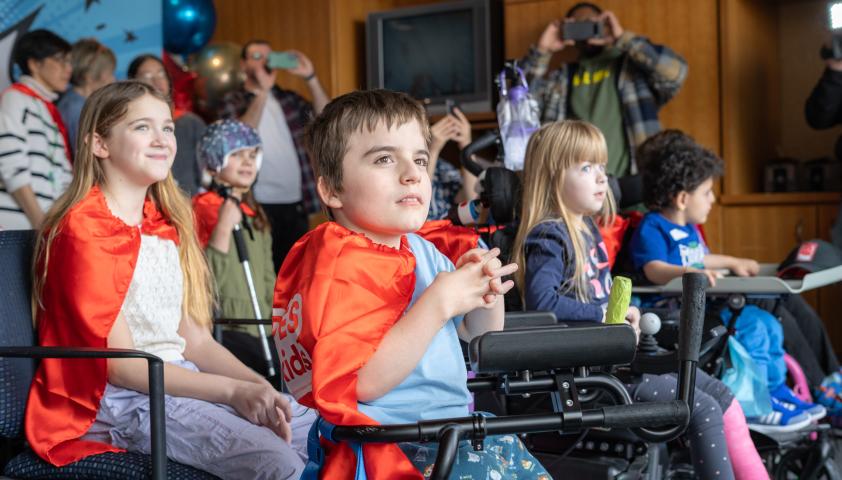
514,120,765,479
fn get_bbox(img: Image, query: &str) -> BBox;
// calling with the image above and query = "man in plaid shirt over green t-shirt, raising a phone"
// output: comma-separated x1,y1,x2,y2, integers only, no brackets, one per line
520,2,687,177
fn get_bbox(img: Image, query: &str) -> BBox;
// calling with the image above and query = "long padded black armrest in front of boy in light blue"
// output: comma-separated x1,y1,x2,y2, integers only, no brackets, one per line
468,324,637,374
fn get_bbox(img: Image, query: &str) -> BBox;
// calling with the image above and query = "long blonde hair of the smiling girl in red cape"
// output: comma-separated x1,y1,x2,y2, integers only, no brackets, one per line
32,80,214,327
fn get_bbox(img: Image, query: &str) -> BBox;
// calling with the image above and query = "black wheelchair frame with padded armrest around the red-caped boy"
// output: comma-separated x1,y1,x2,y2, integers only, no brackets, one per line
312,274,705,479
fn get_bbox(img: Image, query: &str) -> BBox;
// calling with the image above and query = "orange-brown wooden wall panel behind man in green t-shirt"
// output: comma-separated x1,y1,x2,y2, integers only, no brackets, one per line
504,0,720,152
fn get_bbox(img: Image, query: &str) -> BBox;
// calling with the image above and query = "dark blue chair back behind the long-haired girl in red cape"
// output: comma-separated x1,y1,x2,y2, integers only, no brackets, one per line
0,230,35,439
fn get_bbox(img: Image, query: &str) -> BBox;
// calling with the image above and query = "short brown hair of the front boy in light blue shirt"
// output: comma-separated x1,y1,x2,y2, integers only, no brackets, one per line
305,90,430,209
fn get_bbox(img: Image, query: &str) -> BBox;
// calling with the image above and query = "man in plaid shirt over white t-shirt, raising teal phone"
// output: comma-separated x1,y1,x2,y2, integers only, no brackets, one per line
218,40,330,271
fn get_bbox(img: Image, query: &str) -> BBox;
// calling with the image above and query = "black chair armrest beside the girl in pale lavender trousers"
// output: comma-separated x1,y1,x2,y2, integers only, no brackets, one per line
0,346,167,480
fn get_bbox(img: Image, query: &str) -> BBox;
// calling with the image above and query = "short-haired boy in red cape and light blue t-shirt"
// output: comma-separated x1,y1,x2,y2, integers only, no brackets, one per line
272,90,549,480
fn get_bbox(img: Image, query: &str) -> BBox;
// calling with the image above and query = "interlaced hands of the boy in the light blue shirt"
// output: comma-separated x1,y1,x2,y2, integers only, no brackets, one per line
436,248,517,319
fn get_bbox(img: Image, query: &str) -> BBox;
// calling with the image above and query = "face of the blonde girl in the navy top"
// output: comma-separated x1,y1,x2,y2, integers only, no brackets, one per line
561,162,608,215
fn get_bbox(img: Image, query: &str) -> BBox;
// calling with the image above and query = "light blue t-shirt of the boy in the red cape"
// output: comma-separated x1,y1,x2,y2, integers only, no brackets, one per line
358,234,472,425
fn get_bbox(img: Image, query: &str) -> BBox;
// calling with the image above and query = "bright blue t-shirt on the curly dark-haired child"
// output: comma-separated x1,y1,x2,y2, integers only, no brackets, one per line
631,212,710,270
